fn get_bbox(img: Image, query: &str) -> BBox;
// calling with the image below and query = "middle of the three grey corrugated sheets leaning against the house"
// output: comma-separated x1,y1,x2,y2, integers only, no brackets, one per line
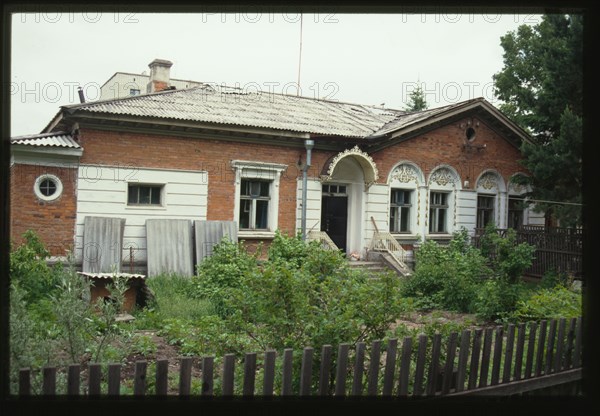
146,219,194,276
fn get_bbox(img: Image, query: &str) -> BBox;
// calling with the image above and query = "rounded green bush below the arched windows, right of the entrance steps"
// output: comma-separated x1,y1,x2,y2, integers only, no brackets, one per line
402,229,490,312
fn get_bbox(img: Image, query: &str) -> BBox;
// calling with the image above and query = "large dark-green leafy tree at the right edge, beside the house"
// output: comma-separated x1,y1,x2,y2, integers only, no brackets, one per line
493,14,583,226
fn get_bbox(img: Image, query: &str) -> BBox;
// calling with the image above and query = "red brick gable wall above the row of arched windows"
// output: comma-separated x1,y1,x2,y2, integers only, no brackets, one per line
371,118,527,184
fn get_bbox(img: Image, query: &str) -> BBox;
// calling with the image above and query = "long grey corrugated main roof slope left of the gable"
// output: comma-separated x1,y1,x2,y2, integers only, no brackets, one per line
63,86,406,138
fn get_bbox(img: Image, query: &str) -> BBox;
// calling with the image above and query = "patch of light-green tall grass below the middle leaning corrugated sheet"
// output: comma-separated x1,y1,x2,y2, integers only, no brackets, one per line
136,273,215,327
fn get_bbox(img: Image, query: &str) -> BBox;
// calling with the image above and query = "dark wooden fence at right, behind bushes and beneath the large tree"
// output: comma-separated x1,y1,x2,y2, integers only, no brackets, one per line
473,225,583,279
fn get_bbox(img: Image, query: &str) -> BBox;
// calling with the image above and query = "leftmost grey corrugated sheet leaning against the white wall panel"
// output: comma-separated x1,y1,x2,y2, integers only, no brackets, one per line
82,216,125,273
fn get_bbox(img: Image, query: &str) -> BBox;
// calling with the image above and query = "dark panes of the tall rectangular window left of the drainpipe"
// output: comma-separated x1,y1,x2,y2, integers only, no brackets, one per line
240,179,271,230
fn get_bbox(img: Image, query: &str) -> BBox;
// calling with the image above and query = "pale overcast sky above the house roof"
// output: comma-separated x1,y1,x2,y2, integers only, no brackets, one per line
10,9,541,136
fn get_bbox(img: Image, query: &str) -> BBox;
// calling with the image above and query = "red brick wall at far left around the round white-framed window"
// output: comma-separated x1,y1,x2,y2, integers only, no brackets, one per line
10,164,77,256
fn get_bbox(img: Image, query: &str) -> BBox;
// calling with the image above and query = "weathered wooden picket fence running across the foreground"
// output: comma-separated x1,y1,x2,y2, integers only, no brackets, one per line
18,317,582,397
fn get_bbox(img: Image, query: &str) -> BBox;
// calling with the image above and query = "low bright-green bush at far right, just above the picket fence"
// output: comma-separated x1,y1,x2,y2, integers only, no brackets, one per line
513,284,582,321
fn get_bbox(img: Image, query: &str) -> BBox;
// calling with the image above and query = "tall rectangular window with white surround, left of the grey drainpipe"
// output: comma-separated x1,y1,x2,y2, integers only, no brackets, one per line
231,160,287,237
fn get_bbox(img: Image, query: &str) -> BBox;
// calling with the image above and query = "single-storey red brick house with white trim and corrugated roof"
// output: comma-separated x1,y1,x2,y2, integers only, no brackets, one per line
11,60,544,274
